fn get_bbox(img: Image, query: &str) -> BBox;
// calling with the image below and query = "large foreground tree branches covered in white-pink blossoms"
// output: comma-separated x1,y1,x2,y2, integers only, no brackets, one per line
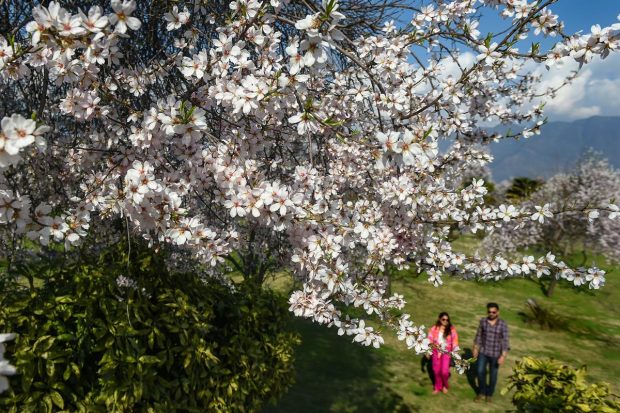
0,0,620,374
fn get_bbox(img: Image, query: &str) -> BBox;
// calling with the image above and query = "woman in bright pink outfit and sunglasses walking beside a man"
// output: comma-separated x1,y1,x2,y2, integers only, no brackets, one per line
428,312,459,394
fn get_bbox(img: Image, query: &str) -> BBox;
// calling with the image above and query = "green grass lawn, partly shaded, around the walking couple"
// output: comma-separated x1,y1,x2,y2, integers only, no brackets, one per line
265,254,620,413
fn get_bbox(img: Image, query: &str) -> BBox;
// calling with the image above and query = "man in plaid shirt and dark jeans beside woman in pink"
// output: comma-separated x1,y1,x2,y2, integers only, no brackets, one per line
474,303,510,403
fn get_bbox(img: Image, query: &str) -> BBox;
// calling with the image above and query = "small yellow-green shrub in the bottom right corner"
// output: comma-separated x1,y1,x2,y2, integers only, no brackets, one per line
502,357,620,413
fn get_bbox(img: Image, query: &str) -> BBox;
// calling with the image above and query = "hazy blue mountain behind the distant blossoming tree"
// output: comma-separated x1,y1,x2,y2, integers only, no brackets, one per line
490,116,620,182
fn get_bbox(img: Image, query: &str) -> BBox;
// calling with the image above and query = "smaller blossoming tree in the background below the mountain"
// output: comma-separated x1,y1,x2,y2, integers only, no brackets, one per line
483,153,620,296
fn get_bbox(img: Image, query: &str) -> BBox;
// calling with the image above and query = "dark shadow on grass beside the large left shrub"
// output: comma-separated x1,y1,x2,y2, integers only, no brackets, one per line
264,319,422,413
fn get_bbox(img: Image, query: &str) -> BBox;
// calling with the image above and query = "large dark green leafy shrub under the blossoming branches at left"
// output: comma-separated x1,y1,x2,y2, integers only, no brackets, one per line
0,244,298,413
